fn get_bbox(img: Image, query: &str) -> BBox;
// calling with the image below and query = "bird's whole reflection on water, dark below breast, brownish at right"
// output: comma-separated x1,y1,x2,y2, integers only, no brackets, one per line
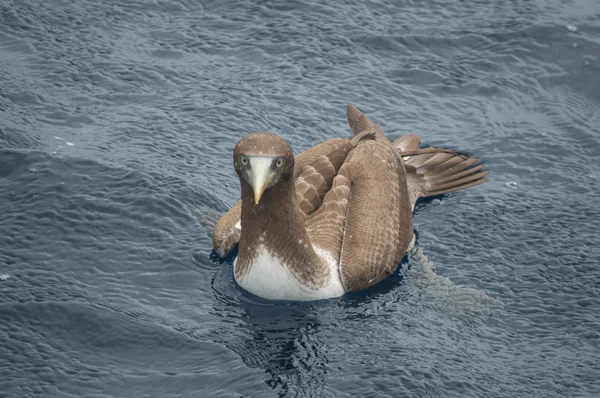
211,244,500,396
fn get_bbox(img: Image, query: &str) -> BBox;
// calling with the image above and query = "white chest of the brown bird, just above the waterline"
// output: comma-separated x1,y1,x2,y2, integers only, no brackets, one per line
233,246,344,301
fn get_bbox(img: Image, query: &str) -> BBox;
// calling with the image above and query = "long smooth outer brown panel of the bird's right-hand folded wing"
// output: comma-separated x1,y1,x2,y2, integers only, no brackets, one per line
340,140,413,291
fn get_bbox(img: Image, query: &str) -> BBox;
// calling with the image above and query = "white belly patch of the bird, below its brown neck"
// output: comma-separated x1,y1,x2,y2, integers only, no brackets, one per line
233,247,345,301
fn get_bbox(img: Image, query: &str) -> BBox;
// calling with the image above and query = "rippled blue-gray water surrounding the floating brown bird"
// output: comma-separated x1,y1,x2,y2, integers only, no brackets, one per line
0,0,600,398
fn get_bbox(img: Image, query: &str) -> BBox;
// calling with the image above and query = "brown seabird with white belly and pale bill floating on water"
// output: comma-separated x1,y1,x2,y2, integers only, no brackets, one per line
212,104,489,301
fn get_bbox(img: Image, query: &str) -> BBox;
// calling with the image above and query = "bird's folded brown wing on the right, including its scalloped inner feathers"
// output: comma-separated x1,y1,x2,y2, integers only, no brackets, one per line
307,132,413,291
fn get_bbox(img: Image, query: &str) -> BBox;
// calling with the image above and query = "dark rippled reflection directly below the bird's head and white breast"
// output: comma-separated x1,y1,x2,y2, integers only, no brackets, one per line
212,264,328,396
